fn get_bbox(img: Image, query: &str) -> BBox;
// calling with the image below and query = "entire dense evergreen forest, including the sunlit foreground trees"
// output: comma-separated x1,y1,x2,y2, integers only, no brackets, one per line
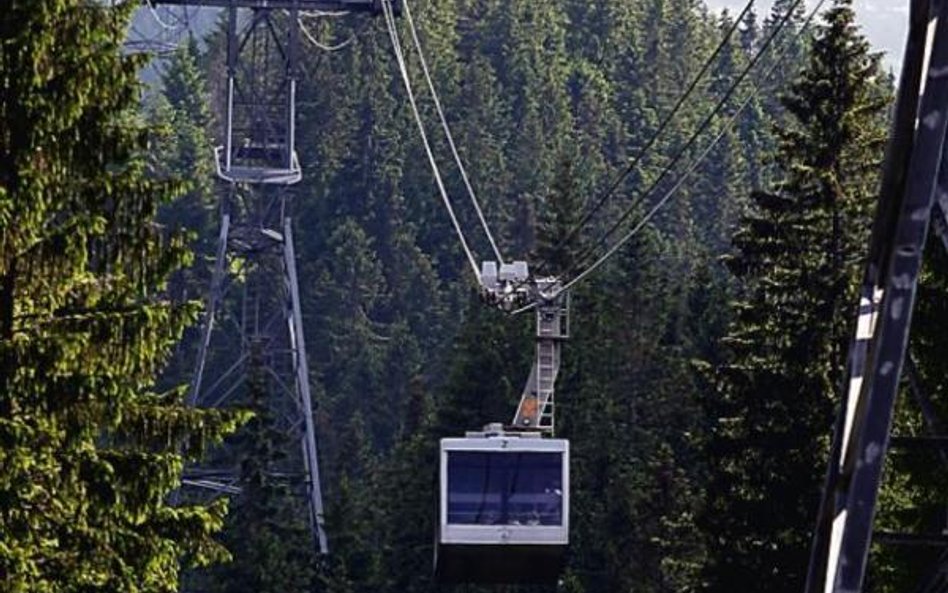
0,0,948,593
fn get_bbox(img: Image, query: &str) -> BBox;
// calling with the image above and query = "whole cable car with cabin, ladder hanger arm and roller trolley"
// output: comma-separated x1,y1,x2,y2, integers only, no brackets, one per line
435,262,569,583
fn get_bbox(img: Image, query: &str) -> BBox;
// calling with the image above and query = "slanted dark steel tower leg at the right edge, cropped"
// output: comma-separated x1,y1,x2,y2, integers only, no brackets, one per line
806,0,948,593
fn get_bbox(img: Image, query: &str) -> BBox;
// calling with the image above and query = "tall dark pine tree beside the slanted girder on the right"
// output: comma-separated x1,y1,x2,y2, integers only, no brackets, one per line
704,0,885,591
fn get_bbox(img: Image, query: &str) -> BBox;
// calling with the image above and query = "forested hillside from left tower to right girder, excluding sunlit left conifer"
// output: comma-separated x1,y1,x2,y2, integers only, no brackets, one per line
143,0,924,593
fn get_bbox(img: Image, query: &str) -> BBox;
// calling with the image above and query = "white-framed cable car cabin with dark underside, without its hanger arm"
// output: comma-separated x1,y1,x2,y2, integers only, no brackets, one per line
435,433,569,583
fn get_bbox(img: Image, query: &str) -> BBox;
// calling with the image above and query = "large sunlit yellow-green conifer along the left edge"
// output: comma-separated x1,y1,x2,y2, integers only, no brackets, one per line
0,0,248,593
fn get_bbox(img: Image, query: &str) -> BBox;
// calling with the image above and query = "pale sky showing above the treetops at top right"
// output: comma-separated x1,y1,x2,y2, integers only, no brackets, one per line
705,0,909,73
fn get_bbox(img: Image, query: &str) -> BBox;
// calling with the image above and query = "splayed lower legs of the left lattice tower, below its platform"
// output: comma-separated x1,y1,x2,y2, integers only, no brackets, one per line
183,186,328,554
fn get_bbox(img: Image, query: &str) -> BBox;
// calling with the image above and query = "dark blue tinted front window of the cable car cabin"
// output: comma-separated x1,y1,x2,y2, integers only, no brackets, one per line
448,451,563,525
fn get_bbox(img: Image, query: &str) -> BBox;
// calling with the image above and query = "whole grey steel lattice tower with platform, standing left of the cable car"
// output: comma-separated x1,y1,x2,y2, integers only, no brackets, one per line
158,0,392,554
